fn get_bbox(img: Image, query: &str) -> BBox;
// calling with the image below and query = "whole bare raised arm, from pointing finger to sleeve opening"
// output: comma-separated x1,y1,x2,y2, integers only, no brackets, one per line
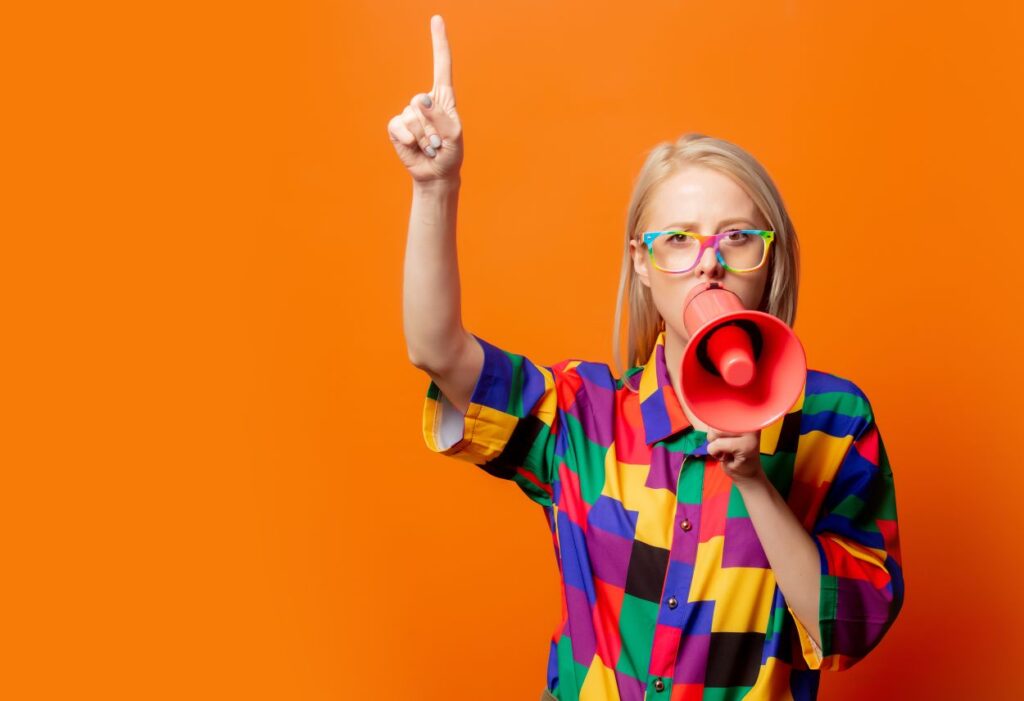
388,15,483,413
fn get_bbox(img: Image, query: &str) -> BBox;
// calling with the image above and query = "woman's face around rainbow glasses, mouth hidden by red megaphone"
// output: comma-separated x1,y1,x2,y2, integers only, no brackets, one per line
630,165,771,342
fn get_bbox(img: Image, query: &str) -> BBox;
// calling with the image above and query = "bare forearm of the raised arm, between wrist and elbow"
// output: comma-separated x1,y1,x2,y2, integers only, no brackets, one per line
402,180,466,370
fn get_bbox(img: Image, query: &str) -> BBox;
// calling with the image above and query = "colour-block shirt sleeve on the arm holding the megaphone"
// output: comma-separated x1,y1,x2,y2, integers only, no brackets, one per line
790,399,903,671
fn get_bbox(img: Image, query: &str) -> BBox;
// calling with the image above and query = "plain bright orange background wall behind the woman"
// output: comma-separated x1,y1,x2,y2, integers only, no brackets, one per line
0,0,1024,700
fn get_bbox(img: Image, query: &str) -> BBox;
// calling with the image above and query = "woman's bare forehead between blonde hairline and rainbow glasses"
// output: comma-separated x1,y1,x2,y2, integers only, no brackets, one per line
646,166,758,227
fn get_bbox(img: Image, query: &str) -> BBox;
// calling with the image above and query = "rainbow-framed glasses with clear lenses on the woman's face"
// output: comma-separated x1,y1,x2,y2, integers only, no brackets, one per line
643,229,775,273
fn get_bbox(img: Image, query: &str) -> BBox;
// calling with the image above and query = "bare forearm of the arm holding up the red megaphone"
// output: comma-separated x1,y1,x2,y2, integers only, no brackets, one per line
735,471,821,647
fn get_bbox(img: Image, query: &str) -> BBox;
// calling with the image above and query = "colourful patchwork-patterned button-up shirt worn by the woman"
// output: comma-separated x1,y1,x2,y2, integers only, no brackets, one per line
423,332,903,701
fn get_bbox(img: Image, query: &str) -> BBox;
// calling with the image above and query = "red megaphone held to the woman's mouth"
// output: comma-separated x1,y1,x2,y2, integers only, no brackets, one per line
680,282,807,433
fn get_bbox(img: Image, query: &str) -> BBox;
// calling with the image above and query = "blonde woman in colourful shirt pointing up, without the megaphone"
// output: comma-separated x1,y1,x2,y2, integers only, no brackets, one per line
388,16,904,701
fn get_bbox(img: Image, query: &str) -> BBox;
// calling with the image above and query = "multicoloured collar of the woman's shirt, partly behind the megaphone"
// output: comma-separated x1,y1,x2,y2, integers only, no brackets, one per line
639,331,804,455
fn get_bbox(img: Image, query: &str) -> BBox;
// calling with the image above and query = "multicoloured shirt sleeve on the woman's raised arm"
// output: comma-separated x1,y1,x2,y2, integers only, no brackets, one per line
423,336,558,507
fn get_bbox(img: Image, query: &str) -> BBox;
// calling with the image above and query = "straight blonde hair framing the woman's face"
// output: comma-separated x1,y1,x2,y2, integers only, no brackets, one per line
611,133,800,380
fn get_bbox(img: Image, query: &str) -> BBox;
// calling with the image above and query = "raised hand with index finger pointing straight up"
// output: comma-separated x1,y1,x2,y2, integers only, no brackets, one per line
387,14,463,182
